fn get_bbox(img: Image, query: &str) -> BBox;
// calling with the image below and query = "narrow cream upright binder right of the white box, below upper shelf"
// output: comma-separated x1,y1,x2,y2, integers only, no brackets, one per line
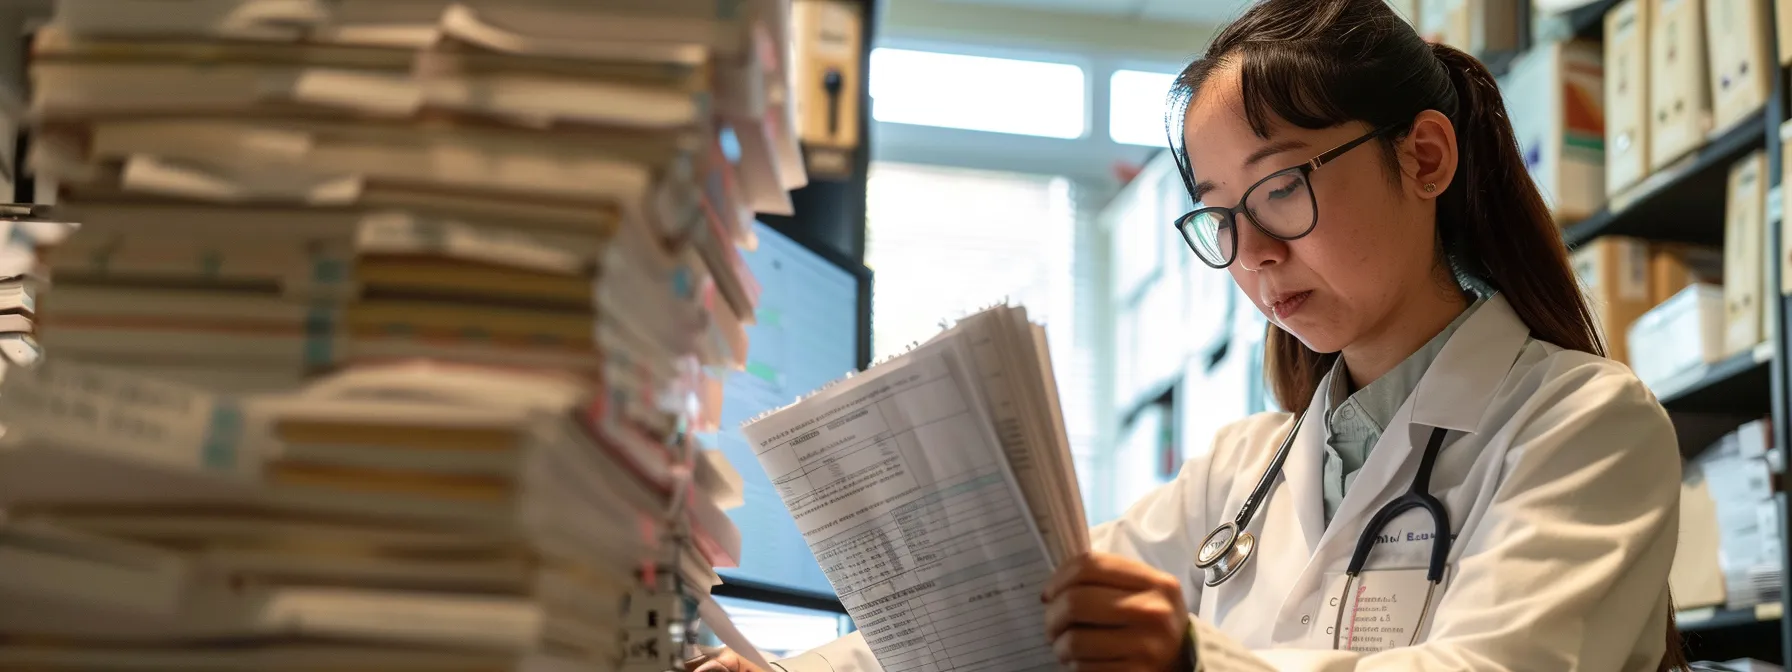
1724,152,1767,353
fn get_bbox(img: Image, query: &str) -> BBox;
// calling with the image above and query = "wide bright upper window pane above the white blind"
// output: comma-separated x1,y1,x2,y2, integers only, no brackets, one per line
871,48,1088,138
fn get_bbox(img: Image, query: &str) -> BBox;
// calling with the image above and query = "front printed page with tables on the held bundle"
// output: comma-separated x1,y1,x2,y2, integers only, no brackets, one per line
742,339,1057,672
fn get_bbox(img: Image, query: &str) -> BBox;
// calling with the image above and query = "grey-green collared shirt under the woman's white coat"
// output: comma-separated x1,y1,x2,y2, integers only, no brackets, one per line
1321,299,1486,525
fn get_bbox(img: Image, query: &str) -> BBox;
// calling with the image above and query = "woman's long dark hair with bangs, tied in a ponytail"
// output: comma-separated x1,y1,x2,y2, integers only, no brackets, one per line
1168,0,1686,670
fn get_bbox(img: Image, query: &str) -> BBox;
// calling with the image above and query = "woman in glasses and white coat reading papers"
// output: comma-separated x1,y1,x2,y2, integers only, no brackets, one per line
695,0,1681,672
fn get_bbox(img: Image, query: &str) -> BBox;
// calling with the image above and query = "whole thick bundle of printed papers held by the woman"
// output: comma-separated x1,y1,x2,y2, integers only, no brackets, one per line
742,306,1090,672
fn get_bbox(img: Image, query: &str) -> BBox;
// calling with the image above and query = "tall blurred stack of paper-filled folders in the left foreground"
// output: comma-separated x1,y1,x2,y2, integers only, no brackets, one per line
0,0,805,672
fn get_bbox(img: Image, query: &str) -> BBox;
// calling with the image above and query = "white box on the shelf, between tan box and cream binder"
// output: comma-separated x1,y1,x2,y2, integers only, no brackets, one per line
1625,283,1724,391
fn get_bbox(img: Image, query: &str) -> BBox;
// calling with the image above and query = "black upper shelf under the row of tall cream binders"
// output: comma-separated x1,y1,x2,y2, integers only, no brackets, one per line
1563,111,1779,247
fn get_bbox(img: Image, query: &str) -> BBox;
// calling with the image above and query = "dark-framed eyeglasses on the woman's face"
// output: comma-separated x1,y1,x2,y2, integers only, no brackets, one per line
1176,124,1403,269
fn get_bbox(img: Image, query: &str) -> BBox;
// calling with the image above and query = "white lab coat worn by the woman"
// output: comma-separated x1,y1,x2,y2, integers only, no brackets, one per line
780,296,1681,672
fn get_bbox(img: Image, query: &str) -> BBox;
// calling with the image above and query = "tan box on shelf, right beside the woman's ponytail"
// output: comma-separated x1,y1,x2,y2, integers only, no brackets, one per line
1572,237,1654,362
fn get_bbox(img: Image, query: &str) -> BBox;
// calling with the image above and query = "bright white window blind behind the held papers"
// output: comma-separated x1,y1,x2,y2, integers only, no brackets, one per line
866,163,1106,516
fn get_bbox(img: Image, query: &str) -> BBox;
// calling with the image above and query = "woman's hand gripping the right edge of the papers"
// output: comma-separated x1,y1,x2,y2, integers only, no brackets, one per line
1043,554,1193,672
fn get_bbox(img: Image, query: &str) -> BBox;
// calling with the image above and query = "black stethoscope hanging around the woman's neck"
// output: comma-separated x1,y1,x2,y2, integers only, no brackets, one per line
1195,410,1452,649
